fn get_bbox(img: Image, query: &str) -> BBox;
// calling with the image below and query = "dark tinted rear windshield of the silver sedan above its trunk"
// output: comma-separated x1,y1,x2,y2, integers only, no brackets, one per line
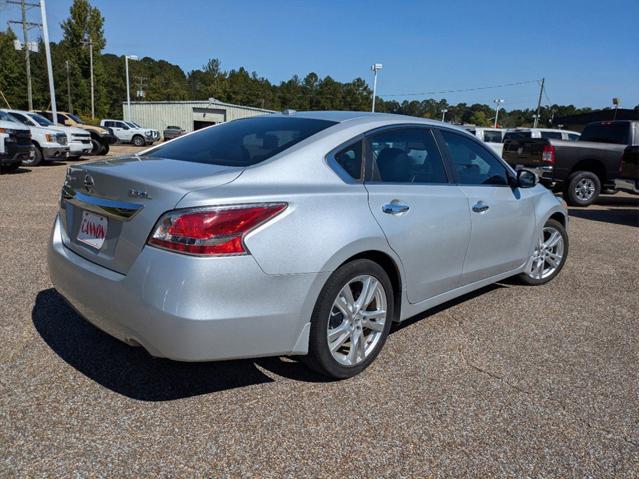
140,116,335,166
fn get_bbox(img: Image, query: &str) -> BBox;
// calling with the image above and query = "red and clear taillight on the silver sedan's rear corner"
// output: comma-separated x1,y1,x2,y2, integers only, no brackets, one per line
148,203,287,256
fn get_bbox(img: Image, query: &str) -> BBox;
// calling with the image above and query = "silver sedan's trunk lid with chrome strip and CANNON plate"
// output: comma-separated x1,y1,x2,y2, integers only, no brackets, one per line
60,156,243,274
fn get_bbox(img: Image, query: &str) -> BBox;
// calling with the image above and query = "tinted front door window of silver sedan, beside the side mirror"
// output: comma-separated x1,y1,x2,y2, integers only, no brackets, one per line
442,131,508,185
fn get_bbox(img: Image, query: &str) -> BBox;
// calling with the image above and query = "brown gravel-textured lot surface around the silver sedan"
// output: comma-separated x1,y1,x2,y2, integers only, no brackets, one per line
0,146,639,477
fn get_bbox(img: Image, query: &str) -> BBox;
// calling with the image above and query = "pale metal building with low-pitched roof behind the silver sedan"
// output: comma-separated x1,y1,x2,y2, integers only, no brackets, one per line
122,99,273,133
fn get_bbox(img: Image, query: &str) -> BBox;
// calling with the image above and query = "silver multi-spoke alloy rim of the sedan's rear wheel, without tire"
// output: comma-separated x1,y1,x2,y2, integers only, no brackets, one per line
326,275,387,366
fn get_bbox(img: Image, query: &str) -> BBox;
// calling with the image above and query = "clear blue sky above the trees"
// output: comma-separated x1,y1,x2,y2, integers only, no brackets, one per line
0,0,639,109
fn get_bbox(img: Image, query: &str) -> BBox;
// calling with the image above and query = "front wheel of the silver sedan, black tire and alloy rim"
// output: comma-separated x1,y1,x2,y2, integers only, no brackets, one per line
519,219,569,286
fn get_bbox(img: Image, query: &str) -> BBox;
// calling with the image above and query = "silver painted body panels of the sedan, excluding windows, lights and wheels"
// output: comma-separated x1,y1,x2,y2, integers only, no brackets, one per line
49,112,567,361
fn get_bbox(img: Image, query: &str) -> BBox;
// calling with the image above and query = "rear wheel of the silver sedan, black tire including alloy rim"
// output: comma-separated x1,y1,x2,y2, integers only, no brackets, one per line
303,259,394,379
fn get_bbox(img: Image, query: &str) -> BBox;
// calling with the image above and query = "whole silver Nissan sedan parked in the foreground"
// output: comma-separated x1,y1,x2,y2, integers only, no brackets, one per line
48,112,568,378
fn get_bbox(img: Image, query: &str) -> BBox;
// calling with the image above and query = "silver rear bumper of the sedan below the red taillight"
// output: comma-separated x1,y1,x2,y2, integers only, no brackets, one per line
48,218,329,361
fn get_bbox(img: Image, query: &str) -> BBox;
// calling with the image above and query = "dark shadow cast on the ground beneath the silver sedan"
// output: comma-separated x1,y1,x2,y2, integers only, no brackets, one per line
32,284,507,401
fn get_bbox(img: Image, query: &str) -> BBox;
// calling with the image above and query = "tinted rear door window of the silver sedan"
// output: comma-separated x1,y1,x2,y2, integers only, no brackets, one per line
368,128,448,183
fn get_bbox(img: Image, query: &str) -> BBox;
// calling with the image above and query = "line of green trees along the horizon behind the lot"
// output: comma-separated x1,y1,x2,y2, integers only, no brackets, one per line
0,0,632,127
